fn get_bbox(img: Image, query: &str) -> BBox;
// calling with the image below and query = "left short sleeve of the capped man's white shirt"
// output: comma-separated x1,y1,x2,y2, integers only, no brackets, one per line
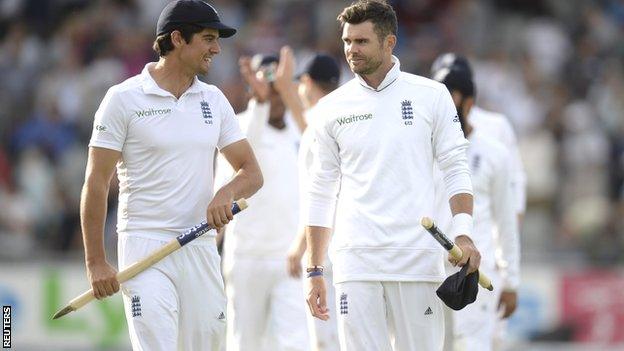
89,88,129,151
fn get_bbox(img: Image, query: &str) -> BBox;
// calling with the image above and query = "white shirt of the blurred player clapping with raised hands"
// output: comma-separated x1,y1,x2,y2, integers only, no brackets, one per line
224,100,301,259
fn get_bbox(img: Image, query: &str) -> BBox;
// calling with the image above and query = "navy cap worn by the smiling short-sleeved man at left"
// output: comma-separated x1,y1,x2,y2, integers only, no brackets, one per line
156,0,236,38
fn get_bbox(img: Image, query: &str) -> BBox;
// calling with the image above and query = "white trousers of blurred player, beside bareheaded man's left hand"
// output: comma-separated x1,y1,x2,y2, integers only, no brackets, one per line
303,260,340,351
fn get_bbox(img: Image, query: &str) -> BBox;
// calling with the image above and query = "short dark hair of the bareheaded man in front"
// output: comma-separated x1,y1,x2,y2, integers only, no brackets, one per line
338,0,397,40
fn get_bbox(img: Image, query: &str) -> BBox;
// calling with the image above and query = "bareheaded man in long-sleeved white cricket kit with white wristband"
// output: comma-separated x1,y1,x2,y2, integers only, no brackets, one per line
306,0,480,351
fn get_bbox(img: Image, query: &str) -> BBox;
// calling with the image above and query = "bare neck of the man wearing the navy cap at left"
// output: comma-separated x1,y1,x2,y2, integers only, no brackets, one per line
150,57,195,99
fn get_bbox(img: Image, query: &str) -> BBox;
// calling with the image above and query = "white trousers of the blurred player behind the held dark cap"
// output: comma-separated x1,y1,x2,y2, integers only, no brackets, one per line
452,266,501,351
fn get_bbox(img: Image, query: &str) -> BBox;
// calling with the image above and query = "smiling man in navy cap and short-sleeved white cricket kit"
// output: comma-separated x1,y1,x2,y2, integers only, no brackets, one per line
81,0,262,351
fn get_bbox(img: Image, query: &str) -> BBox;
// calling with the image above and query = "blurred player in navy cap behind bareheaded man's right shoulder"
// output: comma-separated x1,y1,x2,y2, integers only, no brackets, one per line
433,65,519,351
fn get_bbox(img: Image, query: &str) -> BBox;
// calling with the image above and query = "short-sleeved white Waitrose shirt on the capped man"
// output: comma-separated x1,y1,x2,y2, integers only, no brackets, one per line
89,63,244,239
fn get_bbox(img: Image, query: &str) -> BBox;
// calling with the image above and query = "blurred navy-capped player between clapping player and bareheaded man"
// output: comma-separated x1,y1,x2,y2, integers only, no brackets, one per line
287,53,340,351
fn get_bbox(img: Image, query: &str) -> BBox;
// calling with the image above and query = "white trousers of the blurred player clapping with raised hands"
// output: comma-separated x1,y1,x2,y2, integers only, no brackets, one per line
223,256,310,351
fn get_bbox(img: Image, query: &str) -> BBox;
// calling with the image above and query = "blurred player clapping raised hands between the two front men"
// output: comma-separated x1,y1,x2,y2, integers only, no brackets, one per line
218,47,309,351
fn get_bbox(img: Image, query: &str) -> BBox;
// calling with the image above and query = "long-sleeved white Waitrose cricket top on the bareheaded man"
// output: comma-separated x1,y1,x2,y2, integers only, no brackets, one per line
307,57,472,283
